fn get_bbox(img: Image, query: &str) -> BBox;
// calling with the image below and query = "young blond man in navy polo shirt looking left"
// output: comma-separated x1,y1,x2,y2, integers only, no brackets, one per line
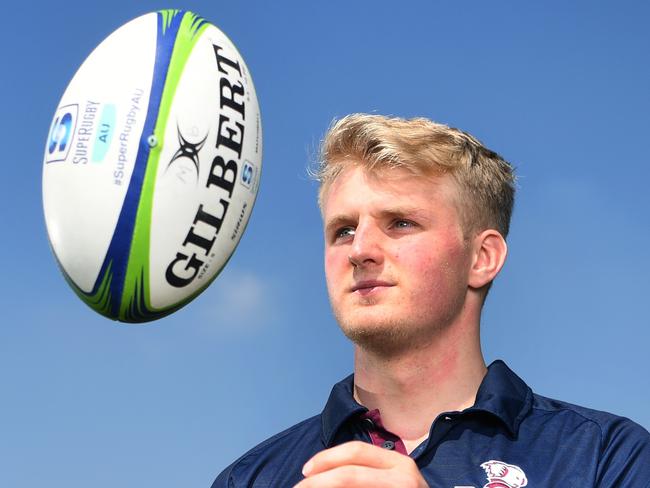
213,115,650,488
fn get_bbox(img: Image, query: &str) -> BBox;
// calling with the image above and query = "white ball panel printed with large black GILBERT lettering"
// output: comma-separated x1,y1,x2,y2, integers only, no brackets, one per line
150,21,261,308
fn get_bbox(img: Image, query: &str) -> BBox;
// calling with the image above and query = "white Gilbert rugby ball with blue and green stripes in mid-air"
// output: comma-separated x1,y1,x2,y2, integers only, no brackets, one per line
43,10,262,322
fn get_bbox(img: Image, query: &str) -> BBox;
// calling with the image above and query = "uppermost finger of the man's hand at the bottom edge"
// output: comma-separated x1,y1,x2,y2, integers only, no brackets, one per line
302,441,408,476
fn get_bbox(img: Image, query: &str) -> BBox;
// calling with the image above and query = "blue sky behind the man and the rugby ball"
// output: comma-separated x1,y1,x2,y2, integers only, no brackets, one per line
0,0,650,488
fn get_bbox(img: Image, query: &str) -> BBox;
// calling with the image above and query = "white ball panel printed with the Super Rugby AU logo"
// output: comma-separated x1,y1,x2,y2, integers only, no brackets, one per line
43,16,156,293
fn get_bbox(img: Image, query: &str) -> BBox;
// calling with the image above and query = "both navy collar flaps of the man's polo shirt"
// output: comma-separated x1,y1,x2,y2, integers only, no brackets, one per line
321,360,532,446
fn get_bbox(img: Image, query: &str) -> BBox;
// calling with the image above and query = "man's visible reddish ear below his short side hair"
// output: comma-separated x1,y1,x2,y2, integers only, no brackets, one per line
468,229,508,288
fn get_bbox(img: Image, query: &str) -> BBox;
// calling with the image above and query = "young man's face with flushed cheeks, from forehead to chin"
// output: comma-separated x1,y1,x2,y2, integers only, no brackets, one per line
323,164,471,352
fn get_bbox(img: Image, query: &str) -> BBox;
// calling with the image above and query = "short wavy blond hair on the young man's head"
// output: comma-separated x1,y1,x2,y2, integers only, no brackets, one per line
314,114,515,238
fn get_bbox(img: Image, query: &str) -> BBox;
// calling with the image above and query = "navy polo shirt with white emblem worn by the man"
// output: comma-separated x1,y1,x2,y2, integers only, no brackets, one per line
212,361,650,488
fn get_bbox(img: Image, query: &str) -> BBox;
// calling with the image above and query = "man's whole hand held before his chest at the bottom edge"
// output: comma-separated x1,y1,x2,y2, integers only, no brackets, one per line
294,441,429,488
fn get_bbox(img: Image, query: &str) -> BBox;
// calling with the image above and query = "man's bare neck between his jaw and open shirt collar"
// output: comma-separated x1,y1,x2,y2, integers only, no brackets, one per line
354,318,487,452
